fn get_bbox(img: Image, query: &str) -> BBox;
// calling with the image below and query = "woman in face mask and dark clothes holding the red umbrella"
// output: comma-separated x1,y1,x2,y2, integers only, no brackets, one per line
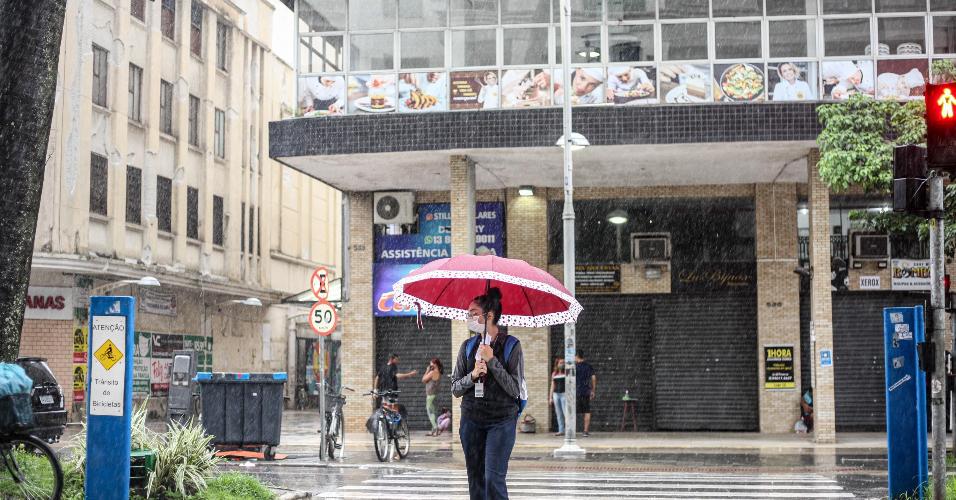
452,287,524,500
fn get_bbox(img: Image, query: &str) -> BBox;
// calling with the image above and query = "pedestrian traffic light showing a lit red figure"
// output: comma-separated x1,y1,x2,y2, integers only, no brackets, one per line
925,83,956,179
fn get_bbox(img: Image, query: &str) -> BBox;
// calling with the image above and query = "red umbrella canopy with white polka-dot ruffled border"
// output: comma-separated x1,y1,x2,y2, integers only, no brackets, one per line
392,255,582,328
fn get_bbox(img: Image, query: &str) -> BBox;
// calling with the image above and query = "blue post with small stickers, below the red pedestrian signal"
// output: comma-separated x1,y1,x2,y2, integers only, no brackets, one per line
883,306,929,499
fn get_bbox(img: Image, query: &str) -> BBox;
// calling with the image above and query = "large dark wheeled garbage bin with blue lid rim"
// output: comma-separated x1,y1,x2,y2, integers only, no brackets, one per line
196,372,288,460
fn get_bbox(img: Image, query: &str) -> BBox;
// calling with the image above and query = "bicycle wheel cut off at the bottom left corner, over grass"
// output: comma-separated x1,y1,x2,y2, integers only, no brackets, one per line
0,436,63,500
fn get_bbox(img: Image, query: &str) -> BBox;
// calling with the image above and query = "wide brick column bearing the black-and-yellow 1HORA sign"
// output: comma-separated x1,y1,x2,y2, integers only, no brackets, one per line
754,184,804,433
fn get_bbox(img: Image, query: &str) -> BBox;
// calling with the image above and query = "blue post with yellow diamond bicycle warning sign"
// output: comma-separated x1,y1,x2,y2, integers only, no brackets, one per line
85,297,136,500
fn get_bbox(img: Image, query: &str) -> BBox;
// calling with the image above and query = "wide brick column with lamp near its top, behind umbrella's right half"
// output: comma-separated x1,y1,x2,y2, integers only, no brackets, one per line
505,188,556,432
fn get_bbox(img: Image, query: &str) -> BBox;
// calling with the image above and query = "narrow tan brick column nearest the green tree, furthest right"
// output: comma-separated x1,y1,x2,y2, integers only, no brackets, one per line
807,148,836,443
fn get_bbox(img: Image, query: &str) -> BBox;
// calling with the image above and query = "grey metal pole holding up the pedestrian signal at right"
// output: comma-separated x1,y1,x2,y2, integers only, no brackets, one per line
927,172,946,498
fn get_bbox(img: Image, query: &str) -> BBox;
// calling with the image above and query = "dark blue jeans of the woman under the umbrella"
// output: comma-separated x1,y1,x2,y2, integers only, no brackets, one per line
458,417,518,500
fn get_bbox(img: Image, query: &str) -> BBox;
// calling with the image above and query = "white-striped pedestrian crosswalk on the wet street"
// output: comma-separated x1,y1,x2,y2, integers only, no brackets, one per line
318,470,854,500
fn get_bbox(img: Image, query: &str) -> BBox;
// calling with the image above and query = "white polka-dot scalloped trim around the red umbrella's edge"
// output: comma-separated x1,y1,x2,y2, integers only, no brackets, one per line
392,270,584,328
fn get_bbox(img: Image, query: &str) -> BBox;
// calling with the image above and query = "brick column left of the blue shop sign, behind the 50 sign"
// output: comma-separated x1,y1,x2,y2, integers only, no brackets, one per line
341,193,375,436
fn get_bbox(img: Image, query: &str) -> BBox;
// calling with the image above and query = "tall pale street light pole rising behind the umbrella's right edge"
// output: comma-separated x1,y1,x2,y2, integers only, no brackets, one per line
554,0,589,458
